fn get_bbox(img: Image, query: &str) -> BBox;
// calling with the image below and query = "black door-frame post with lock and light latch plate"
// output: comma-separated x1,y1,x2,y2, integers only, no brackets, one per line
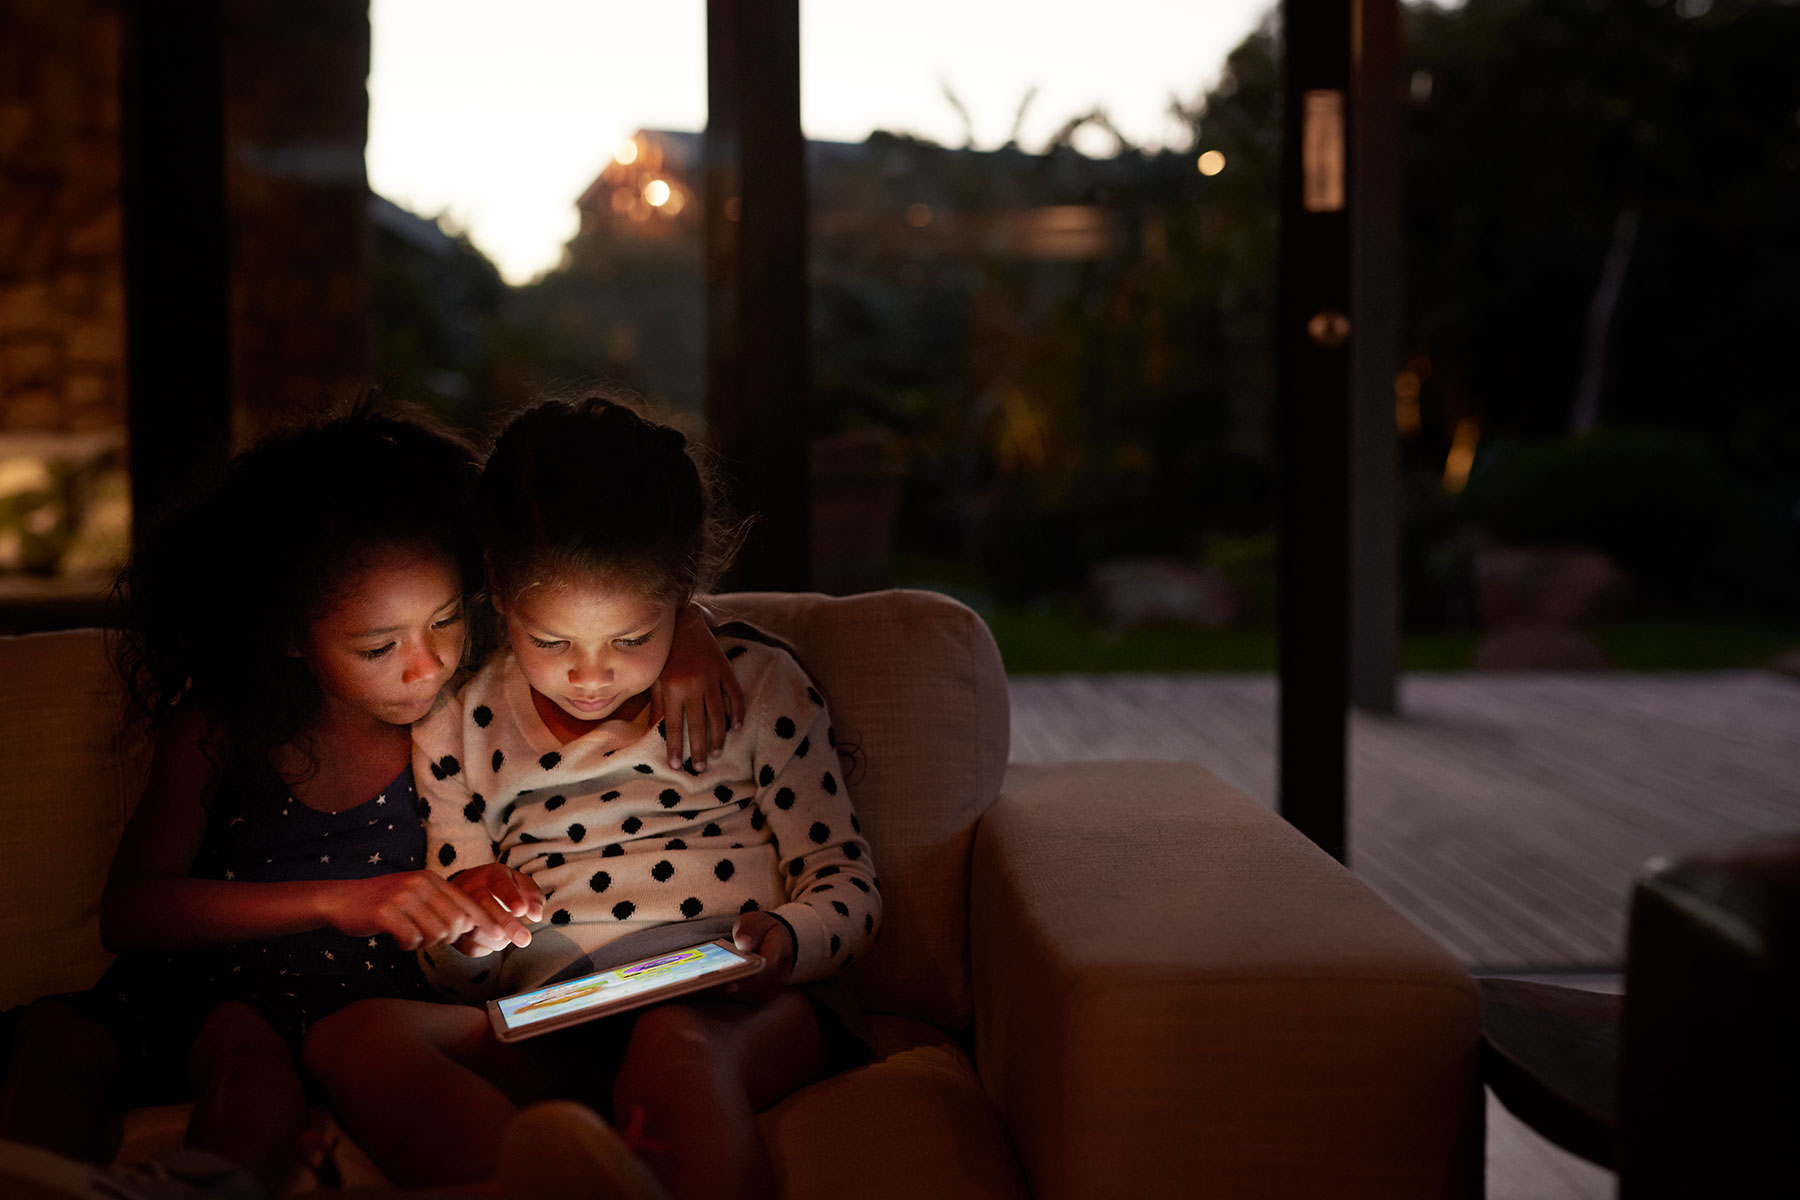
1274,0,1354,858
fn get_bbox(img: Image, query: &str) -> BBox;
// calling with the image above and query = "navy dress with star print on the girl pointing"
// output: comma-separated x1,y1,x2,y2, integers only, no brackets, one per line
49,766,436,1103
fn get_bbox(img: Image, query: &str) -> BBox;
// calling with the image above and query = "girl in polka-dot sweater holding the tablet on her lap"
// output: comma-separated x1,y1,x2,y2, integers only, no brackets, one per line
308,399,882,1200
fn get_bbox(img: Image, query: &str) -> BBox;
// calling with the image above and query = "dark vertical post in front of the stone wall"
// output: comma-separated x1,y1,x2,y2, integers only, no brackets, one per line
121,0,232,529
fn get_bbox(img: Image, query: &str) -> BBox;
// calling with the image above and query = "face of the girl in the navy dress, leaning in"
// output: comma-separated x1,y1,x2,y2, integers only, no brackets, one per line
299,547,468,725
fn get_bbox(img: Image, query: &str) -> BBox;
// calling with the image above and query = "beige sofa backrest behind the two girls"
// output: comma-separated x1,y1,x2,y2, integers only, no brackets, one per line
0,590,1010,1029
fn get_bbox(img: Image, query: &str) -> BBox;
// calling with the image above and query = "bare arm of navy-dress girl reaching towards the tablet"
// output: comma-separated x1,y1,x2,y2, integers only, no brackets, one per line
101,705,511,952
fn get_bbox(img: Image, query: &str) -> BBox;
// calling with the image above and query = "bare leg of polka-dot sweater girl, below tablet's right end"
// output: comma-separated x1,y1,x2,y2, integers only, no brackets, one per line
612,990,828,1200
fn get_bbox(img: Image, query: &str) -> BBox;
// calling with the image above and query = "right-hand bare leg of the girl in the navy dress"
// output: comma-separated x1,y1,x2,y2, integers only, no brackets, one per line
187,1000,306,1195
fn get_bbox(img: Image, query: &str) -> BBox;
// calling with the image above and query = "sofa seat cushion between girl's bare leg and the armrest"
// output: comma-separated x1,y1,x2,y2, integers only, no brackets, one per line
760,1016,1028,1200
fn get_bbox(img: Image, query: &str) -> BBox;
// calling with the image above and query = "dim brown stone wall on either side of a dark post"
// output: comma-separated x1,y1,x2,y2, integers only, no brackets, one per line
0,0,373,441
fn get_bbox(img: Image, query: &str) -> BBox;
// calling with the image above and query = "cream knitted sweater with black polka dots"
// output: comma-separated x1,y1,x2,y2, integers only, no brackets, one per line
414,637,882,984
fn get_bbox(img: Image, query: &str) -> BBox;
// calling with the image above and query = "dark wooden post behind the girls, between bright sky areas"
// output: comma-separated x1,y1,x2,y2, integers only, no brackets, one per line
706,0,812,590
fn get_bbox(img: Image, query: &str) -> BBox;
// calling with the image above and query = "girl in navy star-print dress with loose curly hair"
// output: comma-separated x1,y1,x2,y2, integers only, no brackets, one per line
0,401,745,1193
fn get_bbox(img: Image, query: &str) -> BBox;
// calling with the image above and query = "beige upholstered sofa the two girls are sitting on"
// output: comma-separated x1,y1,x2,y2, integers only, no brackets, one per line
0,592,1481,1200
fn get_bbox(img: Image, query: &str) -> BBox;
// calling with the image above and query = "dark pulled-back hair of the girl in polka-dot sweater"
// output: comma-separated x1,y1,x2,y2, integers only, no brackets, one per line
475,392,742,604
